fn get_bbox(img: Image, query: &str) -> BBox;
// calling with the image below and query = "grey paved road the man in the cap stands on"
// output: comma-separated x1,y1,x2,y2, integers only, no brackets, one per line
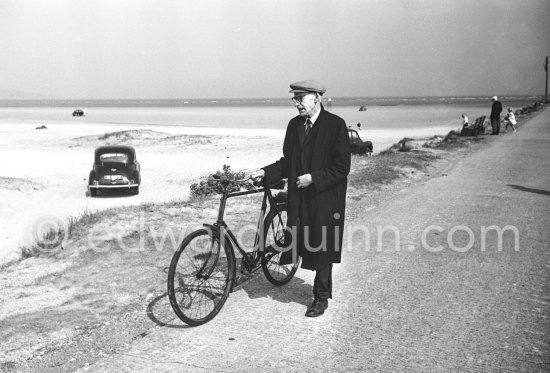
82,110,550,372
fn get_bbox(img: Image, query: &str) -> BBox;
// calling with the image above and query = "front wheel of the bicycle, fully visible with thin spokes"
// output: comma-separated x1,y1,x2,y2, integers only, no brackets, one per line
168,229,235,326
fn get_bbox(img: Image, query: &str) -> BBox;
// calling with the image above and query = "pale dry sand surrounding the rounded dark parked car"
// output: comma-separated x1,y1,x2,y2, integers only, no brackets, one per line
0,122,284,263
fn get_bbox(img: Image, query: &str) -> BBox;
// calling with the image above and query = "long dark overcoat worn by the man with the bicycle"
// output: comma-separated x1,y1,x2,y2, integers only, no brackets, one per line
264,107,351,270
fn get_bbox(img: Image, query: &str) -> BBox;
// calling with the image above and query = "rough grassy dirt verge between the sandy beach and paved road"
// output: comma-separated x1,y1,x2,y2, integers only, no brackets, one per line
0,133,492,372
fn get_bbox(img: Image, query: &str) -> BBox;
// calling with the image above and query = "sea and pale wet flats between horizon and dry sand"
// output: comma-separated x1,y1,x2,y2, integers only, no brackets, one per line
0,95,542,152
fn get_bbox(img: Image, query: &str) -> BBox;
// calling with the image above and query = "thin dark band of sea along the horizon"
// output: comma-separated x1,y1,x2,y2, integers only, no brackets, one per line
0,95,543,108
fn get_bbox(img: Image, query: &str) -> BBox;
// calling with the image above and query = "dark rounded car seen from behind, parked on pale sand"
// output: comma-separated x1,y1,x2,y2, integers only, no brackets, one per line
88,145,141,197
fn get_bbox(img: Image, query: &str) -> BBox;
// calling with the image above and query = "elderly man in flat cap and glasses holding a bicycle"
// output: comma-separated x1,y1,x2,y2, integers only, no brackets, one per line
252,80,351,317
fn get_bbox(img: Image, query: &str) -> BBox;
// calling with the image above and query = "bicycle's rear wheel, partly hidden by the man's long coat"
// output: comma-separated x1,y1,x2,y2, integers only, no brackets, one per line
261,207,300,286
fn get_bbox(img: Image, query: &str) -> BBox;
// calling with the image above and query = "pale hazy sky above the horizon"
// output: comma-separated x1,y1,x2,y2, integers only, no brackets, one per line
0,0,550,99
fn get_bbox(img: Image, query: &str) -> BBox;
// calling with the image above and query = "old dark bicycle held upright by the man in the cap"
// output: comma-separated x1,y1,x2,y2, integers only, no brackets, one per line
168,177,299,326
